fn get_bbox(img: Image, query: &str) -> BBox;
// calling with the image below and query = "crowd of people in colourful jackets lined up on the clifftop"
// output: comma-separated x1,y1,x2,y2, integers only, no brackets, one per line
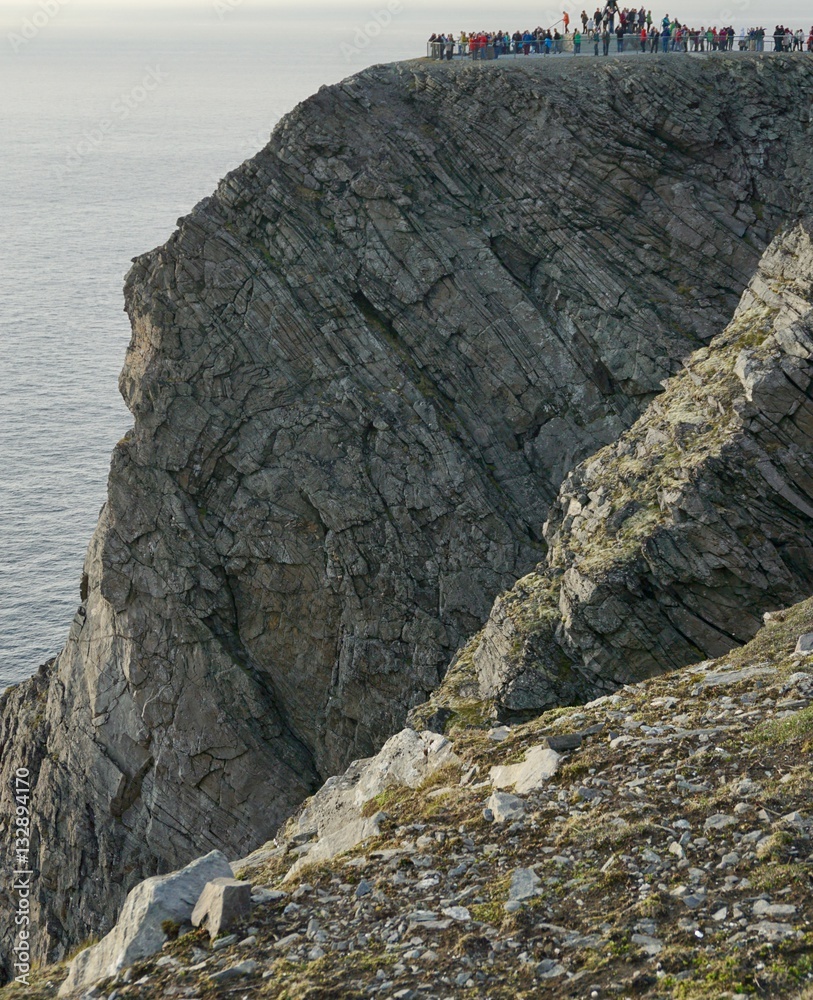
429,8,813,59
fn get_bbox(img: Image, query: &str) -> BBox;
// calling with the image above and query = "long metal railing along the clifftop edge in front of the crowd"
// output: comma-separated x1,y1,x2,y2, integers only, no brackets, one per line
426,32,811,61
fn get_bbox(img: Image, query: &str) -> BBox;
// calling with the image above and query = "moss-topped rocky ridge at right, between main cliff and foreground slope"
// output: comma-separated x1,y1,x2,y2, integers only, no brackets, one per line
415,221,813,723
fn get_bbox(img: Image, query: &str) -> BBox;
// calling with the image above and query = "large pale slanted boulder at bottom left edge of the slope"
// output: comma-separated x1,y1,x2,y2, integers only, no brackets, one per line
59,851,231,997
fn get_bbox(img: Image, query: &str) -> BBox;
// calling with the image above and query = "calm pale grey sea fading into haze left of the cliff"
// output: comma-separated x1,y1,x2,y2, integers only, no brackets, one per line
0,0,438,689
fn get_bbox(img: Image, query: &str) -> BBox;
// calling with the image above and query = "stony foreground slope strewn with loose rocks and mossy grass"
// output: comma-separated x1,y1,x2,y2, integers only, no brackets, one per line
25,600,813,1000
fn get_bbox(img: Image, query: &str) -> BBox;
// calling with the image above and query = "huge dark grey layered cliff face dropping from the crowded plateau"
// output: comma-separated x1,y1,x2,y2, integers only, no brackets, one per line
0,57,813,976
